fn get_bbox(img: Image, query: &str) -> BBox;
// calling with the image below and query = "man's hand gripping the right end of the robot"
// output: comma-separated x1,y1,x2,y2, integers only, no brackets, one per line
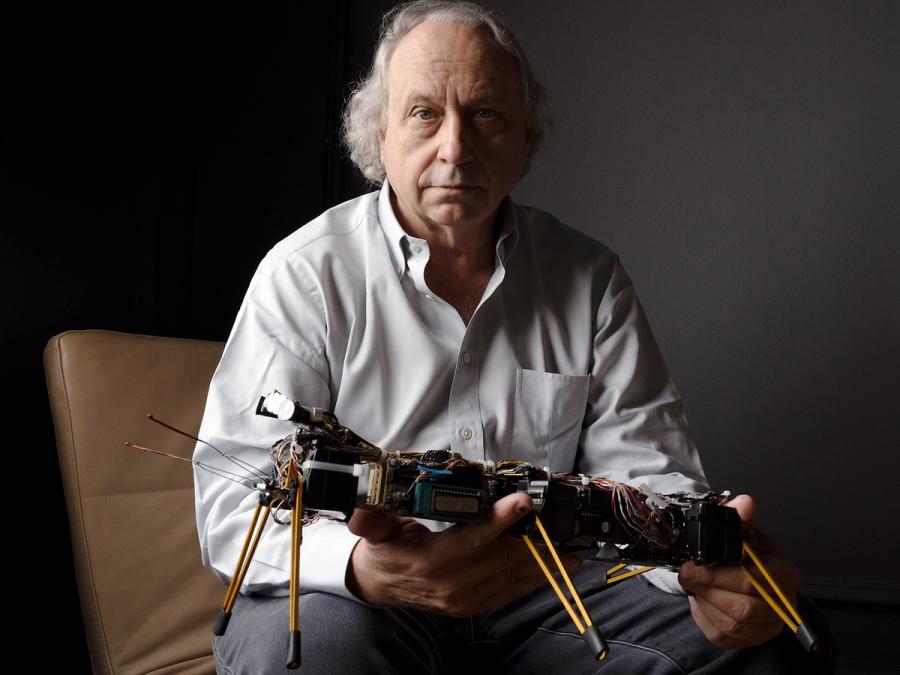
678,495,800,649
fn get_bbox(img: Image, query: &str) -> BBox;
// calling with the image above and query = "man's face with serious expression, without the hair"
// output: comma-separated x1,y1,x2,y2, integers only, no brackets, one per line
381,21,529,234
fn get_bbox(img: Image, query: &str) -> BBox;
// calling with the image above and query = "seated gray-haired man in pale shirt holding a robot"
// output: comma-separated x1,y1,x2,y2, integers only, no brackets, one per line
195,0,824,673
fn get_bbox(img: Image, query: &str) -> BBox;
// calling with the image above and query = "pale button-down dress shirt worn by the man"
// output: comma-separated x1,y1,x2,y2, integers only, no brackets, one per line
194,183,706,599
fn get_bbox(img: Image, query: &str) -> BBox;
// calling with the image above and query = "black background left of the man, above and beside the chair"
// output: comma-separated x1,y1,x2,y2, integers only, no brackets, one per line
0,0,390,672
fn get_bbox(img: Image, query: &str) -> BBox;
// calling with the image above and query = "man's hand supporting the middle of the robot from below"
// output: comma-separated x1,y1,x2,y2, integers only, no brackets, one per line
347,494,581,617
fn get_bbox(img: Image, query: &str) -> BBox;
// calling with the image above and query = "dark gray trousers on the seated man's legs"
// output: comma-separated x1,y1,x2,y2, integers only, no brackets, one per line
213,560,834,675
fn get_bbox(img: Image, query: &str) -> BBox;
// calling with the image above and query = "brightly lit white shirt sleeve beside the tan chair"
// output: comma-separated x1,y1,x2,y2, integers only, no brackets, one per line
194,253,358,599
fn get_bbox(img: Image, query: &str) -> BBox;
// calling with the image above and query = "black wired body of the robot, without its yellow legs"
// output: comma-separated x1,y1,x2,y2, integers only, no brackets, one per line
257,392,741,567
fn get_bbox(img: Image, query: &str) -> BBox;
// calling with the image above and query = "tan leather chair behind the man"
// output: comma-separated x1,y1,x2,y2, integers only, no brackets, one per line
44,331,224,675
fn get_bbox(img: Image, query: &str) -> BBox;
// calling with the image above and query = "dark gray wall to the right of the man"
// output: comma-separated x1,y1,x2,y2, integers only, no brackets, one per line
484,0,900,671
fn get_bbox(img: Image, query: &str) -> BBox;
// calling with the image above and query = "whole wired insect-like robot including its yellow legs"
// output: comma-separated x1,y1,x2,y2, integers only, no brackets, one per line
204,392,818,668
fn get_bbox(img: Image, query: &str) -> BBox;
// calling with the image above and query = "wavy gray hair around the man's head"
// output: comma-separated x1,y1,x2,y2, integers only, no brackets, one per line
341,0,547,184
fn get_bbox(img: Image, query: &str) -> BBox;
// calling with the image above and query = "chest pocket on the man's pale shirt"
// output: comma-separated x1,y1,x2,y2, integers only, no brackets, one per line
509,368,591,473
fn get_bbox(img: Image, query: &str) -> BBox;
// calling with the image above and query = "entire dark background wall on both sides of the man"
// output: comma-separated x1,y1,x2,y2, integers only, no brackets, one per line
0,0,900,672
